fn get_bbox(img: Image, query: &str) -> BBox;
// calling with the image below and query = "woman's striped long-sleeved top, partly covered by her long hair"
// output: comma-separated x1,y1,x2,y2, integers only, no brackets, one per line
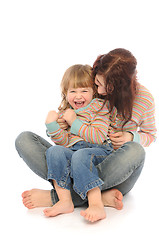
107,84,157,147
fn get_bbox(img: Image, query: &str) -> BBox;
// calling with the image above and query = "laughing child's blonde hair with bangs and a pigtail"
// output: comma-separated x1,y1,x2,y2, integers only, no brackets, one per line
58,64,97,111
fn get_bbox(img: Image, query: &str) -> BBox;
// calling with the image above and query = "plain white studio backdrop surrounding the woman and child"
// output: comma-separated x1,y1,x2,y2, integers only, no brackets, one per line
0,0,159,239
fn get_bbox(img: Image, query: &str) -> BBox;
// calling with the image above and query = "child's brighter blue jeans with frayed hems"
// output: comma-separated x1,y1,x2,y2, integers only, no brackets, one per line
46,141,113,200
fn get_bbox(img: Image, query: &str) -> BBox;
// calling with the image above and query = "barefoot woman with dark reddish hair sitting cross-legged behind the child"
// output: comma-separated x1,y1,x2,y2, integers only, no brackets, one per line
16,49,156,209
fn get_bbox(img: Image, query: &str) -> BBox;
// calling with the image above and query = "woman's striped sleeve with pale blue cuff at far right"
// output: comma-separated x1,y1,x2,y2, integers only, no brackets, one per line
132,102,157,147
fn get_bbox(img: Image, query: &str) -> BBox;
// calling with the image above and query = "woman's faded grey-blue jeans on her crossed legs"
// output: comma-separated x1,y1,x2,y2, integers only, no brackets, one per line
15,132,145,206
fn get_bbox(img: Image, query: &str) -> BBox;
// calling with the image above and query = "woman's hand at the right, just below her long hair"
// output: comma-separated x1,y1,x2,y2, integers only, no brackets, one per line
109,132,133,149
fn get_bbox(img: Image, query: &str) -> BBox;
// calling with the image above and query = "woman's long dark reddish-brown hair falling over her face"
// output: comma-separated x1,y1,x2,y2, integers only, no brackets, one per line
93,48,137,126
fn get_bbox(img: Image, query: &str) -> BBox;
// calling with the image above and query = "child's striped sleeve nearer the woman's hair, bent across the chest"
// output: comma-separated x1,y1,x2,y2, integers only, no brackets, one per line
71,112,109,144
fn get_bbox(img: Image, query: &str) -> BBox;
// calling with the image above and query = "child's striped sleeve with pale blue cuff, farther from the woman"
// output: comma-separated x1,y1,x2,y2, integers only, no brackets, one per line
46,121,69,146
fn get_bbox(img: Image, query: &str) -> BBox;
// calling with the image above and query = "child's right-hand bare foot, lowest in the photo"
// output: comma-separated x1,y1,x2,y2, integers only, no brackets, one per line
80,204,106,222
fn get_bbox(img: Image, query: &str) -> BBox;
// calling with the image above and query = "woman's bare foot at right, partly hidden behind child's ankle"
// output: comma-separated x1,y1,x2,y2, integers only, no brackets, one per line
102,189,123,210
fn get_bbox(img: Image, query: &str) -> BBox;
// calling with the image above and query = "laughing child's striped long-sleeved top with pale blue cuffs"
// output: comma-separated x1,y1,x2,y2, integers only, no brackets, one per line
46,98,110,147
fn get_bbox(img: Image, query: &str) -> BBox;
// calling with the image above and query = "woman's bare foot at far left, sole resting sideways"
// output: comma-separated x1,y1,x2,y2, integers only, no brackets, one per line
22,189,52,209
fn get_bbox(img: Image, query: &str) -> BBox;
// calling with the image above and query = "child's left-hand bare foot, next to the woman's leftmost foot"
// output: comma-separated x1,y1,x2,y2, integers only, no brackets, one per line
43,200,74,217
